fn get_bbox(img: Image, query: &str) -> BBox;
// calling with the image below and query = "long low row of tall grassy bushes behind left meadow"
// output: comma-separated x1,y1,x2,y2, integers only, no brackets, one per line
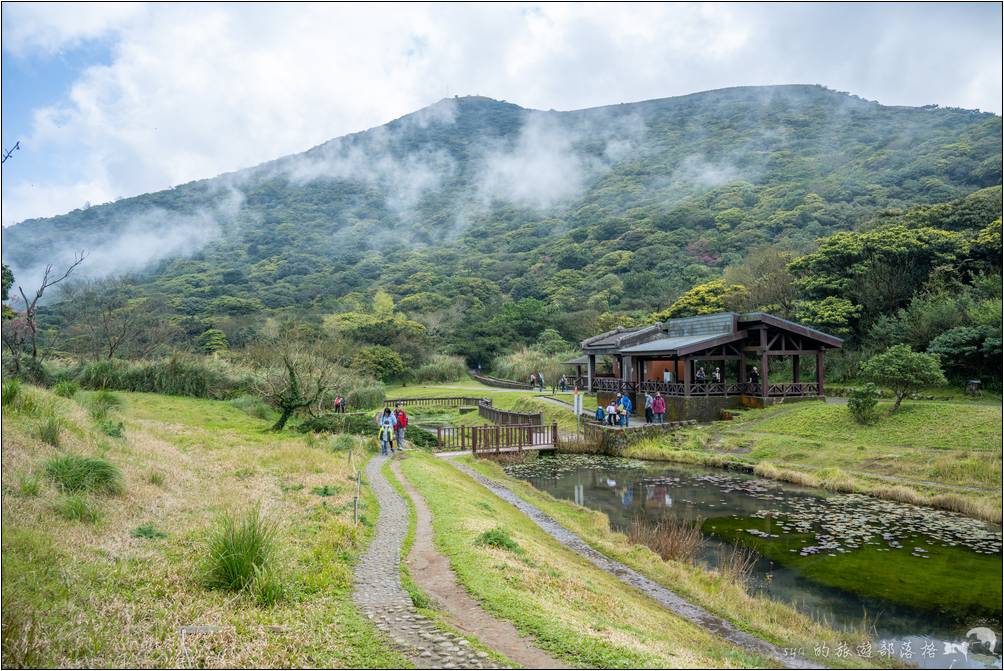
75,355,251,399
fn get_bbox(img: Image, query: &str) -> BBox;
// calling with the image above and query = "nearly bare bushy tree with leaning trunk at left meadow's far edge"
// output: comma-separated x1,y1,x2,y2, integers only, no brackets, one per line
254,343,334,431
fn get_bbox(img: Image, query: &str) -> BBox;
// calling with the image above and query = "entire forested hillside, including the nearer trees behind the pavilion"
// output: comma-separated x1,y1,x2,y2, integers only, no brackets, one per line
4,85,1002,375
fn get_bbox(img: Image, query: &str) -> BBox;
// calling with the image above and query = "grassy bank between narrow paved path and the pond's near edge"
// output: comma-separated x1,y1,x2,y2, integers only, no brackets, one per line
464,457,891,667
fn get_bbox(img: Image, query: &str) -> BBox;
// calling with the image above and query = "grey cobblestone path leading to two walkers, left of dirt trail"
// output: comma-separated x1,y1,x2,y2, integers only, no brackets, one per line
352,457,497,669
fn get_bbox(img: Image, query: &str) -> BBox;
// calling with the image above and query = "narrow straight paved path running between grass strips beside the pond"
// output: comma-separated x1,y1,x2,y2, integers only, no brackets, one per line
446,458,823,669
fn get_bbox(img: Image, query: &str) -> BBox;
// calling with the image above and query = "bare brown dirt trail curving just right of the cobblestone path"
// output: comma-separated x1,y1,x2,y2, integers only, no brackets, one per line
391,462,569,669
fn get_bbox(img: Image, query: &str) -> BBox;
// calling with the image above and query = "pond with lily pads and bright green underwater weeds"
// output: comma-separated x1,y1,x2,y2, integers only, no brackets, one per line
506,454,1002,668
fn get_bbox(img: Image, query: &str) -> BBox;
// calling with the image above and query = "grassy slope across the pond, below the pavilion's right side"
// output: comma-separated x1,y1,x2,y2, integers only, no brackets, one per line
624,401,1002,521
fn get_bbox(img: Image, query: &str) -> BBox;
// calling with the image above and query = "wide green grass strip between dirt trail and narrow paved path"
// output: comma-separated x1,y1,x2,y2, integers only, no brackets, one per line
402,455,771,668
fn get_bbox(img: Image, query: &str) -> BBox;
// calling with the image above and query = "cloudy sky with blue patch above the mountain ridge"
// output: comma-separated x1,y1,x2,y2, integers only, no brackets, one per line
2,3,1002,225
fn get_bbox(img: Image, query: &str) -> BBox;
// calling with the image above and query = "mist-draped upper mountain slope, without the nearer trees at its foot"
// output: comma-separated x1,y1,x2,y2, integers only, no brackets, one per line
3,85,1002,329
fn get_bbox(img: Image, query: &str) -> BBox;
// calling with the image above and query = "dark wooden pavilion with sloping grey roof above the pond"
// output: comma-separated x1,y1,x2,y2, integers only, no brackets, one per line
569,312,842,414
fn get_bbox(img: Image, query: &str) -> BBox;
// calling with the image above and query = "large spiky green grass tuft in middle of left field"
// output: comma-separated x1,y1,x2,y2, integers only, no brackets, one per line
205,506,276,592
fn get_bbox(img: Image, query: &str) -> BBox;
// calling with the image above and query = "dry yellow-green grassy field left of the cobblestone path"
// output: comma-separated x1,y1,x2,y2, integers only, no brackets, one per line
3,387,408,667
